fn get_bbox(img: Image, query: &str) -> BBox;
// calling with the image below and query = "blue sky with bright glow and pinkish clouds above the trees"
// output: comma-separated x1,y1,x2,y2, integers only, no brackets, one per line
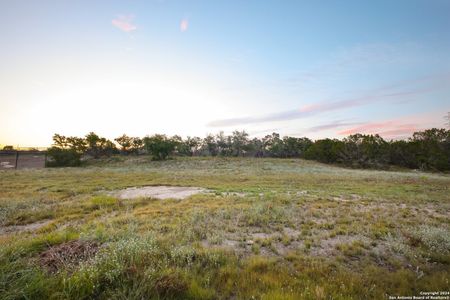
0,0,450,146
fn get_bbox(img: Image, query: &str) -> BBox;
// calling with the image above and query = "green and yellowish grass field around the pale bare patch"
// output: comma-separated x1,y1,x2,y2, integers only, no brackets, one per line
0,157,450,299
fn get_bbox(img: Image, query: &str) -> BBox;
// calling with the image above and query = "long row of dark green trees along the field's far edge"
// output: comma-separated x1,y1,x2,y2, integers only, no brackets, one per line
48,128,450,171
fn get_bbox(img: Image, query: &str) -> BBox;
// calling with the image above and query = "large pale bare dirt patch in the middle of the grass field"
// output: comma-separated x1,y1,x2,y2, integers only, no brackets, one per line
115,186,206,199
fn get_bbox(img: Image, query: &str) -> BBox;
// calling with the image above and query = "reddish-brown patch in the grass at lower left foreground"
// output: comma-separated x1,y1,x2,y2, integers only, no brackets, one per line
39,240,99,273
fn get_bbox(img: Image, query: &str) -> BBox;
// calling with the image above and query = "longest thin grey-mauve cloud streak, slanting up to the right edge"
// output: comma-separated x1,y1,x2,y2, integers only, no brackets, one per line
207,74,450,127
